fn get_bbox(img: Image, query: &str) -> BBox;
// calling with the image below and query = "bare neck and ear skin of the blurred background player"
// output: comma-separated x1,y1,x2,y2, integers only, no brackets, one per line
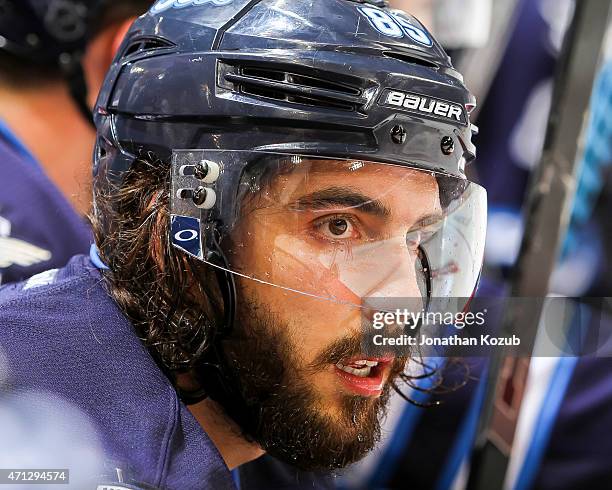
0,18,134,215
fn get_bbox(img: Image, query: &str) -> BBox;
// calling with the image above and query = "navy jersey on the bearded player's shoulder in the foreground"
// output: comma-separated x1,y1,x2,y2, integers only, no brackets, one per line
0,256,332,490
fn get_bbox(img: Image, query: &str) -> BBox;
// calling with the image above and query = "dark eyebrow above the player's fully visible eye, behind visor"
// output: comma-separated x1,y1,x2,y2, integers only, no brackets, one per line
291,187,391,218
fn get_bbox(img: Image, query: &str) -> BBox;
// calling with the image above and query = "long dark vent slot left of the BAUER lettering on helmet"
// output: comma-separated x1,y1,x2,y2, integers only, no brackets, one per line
222,65,367,111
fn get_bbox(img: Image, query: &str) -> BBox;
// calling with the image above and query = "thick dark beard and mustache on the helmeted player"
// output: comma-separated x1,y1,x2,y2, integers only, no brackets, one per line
210,298,405,471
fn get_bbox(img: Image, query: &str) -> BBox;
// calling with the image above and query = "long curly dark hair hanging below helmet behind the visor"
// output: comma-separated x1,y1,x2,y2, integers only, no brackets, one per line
90,152,223,377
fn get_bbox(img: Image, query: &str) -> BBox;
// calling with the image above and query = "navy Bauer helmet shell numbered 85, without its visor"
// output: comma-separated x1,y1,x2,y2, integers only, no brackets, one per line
95,0,475,181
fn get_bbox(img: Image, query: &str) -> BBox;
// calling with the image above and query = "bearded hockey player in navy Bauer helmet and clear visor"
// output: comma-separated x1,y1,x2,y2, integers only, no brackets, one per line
0,0,486,489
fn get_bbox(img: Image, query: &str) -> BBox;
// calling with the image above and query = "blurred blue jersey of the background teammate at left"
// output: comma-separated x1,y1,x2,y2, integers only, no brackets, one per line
0,121,92,284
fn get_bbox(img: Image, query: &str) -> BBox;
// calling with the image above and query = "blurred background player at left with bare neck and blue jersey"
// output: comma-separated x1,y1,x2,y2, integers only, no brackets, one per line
0,0,152,283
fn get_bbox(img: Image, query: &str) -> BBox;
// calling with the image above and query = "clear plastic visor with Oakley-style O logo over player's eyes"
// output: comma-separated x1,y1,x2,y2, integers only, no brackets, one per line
171,150,486,306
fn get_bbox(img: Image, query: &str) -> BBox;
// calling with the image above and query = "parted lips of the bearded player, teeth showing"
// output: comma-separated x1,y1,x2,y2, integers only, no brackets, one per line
334,357,393,397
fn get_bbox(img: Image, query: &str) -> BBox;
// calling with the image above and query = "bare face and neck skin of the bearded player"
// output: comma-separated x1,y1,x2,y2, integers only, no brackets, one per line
190,161,441,468
